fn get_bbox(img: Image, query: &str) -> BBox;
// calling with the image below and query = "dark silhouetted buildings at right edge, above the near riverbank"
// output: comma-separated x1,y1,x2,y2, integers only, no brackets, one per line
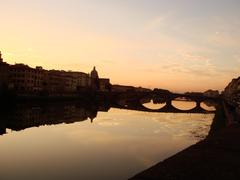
223,77,240,118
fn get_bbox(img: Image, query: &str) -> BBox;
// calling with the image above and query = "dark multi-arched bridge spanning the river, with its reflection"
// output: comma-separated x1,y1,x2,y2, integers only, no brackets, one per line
111,92,220,113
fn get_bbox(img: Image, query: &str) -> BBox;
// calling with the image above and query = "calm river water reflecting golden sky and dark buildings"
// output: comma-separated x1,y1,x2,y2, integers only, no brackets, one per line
0,102,214,180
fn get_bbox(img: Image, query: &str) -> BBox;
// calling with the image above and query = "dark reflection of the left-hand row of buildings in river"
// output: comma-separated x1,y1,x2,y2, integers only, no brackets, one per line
0,104,109,135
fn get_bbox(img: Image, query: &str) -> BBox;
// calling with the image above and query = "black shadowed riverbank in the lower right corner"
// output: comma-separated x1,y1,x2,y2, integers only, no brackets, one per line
131,107,240,180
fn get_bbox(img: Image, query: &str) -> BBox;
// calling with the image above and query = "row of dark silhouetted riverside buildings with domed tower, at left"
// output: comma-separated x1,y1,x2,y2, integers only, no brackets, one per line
0,52,110,95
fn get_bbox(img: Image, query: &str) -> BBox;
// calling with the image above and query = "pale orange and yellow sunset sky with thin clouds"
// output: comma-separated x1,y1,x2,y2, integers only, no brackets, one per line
0,0,240,92
